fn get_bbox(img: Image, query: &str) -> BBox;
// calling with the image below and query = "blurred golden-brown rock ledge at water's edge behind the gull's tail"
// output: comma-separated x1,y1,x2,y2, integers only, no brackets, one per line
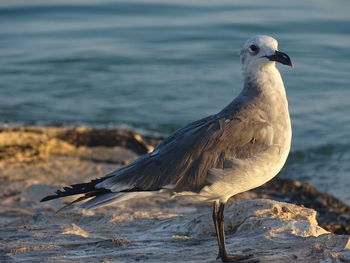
0,126,159,163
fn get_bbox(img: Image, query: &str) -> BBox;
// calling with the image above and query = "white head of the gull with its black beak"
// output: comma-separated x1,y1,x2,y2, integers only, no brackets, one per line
241,35,292,74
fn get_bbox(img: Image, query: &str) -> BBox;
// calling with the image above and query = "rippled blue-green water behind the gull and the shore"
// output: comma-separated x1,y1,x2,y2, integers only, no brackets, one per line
0,0,350,203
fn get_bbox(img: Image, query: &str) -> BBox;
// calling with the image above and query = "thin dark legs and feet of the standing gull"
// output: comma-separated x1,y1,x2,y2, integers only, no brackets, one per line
213,202,251,262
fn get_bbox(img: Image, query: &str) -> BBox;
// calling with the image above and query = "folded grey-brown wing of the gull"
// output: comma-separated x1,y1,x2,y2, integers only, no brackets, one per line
96,99,274,192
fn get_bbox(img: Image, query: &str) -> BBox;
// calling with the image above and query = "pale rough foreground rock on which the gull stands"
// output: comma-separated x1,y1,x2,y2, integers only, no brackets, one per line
0,199,350,263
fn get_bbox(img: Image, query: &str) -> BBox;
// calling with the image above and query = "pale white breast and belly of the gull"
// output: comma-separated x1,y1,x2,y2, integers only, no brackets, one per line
200,69,292,202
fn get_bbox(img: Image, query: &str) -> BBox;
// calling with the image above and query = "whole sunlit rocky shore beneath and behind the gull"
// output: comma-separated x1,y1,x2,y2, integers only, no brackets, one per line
0,126,350,262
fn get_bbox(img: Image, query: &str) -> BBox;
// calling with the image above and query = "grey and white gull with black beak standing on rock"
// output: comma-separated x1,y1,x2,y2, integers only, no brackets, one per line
41,35,292,262
